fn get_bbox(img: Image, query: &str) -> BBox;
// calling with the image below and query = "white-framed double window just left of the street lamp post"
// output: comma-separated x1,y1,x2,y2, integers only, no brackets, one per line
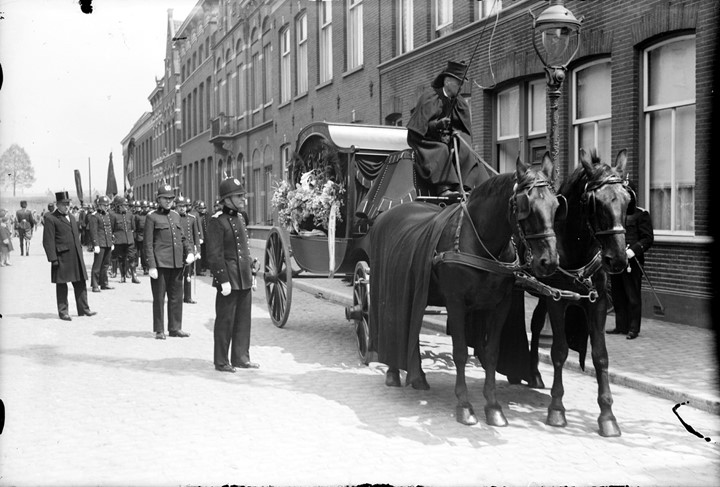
495,80,547,172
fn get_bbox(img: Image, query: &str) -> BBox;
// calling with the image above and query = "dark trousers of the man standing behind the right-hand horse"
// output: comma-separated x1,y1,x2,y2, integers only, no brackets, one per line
610,259,642,334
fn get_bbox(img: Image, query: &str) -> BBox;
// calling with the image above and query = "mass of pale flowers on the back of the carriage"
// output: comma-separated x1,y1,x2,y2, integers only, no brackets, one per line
272,169,345,233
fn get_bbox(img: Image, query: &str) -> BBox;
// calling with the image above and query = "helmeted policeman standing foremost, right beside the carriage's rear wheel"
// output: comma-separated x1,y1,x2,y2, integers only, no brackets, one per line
207,178,259,372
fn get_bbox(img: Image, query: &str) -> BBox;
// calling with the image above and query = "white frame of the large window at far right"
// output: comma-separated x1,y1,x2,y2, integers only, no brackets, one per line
638,34,697,237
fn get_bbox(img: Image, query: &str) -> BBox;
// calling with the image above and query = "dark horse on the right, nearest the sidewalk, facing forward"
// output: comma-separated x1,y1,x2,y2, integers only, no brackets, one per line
530,149,630,436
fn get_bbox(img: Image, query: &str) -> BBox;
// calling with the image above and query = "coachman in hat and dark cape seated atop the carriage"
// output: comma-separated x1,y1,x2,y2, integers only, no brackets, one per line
407,61,488,196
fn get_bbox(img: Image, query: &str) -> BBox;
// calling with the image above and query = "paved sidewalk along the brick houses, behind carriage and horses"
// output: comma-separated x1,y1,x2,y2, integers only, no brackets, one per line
251,240,720,414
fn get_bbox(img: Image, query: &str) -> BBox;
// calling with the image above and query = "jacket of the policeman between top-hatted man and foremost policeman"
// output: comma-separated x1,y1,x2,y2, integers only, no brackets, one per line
143,208,193,269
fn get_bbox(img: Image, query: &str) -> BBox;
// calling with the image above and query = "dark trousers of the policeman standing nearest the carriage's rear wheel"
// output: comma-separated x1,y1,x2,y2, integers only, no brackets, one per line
213,289,252,367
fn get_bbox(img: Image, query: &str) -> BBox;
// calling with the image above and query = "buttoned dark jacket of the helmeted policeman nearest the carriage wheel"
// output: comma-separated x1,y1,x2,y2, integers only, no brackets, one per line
205,207,252,290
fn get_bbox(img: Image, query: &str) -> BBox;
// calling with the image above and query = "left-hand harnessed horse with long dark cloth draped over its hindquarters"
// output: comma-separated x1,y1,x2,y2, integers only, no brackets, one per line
370,154,559,426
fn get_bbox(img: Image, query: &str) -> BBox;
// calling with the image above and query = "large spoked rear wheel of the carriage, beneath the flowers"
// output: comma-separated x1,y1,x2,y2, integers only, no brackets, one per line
263,228,292,328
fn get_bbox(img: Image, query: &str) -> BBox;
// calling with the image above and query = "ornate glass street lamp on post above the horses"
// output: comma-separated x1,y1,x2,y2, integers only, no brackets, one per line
530,0,584,183
